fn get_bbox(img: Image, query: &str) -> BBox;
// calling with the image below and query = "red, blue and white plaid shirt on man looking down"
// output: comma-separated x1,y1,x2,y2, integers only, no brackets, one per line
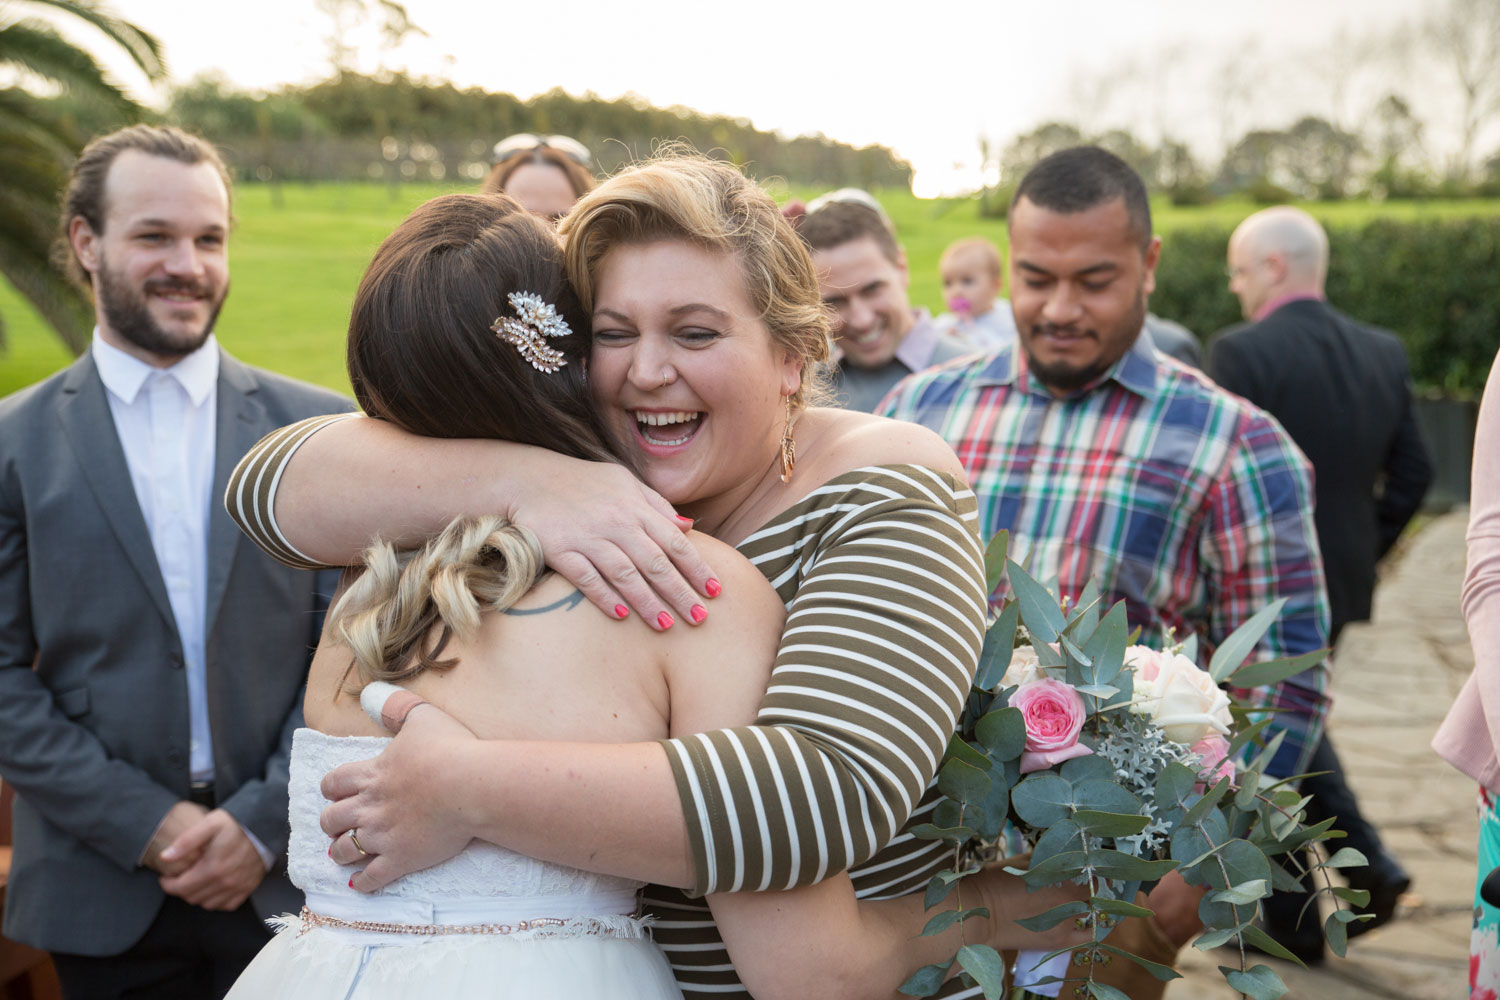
876,332,1329,777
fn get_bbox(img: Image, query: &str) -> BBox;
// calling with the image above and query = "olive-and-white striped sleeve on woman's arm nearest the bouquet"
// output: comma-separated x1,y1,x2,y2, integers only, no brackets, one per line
665,466,984,894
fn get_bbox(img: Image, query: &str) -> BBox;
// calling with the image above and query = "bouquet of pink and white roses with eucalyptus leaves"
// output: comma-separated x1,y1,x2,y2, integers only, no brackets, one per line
902,532,1368,1000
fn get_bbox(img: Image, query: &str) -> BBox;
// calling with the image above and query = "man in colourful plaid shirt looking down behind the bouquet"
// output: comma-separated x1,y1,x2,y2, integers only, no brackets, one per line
876,147,1329,996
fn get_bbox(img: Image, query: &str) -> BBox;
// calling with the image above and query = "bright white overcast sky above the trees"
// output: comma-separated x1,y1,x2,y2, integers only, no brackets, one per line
96,0,1424,193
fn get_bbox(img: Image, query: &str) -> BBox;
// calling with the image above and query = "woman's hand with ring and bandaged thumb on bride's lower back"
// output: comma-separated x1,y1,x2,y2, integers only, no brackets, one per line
321,702,479,892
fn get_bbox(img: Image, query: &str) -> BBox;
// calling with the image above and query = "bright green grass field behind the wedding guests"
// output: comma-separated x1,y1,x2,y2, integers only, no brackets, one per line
0,184,1500,396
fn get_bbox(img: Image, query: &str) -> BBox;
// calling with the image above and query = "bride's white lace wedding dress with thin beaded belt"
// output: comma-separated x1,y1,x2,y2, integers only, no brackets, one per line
230,729,683,1000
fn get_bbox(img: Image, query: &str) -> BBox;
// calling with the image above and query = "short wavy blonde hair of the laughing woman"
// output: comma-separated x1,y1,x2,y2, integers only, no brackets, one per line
558,148,830,405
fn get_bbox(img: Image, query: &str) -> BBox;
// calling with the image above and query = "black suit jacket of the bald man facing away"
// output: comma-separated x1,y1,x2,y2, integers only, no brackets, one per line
1208,300,1433,642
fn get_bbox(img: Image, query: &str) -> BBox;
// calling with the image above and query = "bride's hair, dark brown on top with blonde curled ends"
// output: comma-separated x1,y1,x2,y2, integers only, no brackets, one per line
330,195,621,682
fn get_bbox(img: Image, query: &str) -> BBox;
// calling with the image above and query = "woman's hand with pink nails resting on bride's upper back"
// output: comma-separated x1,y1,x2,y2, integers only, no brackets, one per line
510,456,719,630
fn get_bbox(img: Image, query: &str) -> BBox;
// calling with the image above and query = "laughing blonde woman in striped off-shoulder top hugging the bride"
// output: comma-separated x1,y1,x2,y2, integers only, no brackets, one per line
228,157,1086,997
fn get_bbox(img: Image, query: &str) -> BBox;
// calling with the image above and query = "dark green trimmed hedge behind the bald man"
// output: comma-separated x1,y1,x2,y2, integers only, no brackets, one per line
1151,217,1500,396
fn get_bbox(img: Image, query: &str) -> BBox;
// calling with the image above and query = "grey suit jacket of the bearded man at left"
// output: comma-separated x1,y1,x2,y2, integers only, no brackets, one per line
0,352,350,955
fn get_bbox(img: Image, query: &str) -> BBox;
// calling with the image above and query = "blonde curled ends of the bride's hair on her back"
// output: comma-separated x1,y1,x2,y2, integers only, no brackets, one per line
329,516,545,684
